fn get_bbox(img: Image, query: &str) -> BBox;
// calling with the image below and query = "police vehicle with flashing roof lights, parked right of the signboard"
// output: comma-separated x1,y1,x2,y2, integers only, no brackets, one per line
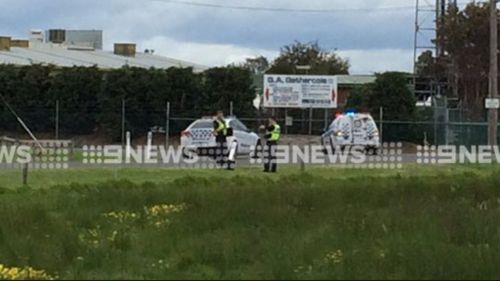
321,112,380,154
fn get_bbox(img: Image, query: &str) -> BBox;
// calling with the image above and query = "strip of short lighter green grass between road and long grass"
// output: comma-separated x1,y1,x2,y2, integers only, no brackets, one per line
0,165,500,189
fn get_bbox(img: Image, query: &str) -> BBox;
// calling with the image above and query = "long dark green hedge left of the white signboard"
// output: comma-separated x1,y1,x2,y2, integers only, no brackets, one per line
0,65,255,140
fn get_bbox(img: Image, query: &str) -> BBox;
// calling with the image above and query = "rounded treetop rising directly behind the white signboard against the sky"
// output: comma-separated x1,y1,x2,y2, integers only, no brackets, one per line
267,41,349,75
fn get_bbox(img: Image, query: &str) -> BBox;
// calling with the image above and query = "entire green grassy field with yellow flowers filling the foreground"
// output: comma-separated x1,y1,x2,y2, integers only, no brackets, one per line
0,166,500,279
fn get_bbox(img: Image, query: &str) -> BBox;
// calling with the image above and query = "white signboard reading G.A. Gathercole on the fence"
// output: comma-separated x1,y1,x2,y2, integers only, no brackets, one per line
263,75,338,108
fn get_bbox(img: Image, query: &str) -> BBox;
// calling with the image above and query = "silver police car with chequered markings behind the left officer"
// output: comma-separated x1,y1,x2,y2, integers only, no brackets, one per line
181,117,261,157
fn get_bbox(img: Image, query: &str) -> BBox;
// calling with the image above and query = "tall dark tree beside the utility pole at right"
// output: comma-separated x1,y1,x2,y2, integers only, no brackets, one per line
417,2,500,119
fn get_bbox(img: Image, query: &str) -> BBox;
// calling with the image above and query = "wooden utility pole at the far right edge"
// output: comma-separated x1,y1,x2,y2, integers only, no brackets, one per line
488,0,498,146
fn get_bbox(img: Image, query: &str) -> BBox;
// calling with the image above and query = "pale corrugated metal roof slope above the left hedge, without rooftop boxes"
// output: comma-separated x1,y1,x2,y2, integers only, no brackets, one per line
0,44,208,72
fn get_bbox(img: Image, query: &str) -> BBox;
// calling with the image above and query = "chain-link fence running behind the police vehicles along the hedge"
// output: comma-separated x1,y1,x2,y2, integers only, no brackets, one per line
0,99,500,145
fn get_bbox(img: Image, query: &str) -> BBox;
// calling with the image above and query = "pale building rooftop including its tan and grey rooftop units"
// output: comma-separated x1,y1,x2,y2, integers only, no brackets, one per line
0,30,208,72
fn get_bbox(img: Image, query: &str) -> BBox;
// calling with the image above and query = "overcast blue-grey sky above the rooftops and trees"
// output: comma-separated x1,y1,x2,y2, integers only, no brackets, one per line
0,0,433,74
